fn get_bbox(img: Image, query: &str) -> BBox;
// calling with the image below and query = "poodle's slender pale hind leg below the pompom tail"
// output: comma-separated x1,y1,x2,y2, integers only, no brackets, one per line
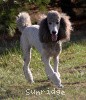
21,35,34,83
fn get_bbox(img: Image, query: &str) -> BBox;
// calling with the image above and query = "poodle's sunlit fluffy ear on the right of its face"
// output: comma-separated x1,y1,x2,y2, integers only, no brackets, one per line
58,14,72,41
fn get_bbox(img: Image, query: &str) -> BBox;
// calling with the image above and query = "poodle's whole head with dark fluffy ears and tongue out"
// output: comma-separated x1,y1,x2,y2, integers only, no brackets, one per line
39,11,72,43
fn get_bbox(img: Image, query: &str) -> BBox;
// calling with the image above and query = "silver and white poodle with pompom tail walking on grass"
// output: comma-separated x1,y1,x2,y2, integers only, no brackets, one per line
16,10,72,88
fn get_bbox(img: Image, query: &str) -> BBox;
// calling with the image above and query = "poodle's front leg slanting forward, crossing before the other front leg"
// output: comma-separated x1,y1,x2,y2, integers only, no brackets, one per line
42,56,62,88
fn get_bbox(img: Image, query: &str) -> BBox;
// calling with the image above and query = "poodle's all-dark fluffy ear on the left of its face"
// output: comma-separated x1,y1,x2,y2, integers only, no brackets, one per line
39,18,52,43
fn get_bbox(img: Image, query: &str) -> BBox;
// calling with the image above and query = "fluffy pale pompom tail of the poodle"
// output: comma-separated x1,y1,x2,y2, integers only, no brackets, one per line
16,12,31,32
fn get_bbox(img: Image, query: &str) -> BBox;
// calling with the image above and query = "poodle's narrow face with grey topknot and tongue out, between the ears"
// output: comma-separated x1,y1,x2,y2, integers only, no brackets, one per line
47,11,61,41
